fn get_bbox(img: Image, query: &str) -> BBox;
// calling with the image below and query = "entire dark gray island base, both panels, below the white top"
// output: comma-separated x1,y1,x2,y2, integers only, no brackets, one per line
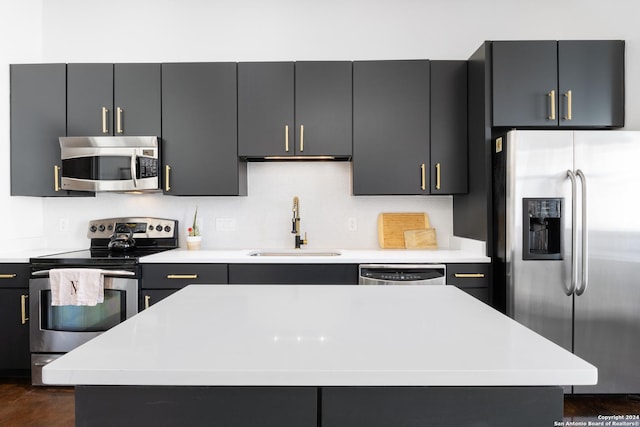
76,386,564,427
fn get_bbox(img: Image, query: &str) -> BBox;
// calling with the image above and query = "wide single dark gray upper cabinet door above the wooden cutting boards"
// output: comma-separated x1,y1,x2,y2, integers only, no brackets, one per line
353,61,430,195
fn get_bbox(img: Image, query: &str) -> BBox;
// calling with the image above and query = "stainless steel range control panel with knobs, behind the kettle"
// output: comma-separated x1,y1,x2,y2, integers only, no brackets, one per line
87,218,178,239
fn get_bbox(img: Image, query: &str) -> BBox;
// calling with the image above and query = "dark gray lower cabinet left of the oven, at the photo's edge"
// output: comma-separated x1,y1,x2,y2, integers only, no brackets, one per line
0,264,31,376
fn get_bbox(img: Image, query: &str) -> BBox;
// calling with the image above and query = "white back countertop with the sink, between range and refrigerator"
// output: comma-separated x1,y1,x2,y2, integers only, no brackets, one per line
140,249,491,264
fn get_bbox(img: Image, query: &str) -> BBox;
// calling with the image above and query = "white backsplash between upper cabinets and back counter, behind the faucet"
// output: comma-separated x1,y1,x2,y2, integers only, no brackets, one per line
44,162,453,249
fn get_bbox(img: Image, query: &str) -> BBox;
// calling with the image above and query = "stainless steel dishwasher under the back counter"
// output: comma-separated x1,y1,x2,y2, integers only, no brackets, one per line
358,264,447,285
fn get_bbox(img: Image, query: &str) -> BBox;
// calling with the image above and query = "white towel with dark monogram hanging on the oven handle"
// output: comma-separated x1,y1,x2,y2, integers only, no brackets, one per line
49,268,105,306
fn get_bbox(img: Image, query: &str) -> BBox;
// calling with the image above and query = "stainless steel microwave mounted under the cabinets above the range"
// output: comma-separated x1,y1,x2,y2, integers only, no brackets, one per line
59,136,160,192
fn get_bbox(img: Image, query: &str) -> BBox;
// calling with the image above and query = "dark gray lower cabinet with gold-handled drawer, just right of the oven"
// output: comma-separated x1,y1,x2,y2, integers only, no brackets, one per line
139,263,227,310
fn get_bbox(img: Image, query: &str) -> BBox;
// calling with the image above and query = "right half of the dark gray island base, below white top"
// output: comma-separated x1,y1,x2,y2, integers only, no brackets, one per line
320,387,564,427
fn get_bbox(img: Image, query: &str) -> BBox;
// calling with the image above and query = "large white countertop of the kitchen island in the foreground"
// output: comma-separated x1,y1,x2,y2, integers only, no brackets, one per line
43,285,597,386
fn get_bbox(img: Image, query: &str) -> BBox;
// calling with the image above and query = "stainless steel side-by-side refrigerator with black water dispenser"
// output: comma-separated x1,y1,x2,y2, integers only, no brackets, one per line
493,131,640,394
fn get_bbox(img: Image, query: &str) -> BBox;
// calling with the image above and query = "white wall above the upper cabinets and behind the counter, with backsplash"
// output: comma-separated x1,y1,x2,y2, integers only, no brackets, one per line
0,0,640,252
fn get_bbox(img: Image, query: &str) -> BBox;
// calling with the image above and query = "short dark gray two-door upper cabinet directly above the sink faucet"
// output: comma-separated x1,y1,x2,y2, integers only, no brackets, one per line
238,62,352,157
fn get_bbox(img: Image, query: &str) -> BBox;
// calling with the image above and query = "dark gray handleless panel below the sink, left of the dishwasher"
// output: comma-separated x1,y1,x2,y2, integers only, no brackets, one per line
229,264,358,285
